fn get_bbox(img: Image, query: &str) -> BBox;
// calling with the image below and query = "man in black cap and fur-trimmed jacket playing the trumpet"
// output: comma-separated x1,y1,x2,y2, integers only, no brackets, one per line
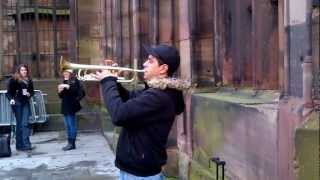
95,45,188,180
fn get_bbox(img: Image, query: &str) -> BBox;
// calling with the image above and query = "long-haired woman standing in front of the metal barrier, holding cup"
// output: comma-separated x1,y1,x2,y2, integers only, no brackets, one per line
7,64,34,151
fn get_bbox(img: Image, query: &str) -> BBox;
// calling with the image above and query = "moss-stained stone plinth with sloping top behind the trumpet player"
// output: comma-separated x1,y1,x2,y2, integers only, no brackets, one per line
189,90,278,180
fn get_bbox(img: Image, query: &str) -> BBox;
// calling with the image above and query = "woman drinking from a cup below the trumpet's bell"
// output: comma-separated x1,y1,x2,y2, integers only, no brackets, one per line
58,69,81,151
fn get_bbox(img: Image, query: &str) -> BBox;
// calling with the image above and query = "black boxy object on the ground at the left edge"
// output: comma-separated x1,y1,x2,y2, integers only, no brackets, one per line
0,127,11,157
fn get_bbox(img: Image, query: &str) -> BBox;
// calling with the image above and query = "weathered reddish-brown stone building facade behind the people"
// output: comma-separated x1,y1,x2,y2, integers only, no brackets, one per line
0,0,320,180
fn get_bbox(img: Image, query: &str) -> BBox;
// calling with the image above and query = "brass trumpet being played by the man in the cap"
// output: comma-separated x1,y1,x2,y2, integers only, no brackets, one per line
60,56,144,83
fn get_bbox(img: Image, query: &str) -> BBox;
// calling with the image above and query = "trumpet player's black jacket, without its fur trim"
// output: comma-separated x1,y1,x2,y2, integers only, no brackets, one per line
101,77,188,176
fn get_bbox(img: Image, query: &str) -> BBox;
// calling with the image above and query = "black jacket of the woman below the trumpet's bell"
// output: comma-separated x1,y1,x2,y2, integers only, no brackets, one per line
58,78,81,115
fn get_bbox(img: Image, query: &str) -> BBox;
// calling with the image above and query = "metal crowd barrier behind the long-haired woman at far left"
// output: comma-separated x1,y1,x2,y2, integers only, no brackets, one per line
0,90,48,126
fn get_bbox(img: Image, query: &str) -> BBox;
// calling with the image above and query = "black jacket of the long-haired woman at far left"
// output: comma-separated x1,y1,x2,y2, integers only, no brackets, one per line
7,78,34,104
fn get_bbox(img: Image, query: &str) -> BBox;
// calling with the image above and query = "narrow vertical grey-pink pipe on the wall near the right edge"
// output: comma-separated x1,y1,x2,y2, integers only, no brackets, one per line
302,0,313,107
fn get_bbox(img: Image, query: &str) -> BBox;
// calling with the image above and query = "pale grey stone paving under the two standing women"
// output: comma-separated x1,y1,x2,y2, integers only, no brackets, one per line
0,132,119,180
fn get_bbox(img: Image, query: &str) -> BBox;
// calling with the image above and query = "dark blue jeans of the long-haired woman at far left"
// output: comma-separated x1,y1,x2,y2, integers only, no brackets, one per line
13,103,31,150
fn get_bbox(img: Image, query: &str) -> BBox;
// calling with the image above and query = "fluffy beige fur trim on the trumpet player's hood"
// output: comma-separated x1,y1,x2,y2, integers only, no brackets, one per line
146,78,191,91
